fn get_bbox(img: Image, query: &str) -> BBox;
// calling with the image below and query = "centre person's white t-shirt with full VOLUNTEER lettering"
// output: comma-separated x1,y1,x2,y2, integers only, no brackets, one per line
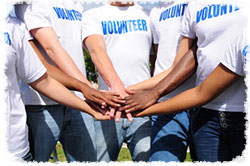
82,4,152,90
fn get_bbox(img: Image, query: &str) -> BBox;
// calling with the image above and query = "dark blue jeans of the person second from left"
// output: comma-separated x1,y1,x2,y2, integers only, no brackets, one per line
26,105,96,162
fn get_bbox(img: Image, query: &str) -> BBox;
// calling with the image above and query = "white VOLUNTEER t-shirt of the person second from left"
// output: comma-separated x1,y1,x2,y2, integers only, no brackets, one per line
15,0,86,105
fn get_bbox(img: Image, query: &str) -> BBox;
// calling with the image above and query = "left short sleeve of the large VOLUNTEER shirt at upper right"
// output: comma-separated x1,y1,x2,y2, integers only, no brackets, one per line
180,2,196,39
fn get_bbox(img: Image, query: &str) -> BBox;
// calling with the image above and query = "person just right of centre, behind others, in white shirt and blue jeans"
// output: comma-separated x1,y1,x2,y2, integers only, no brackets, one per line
123,0,195,162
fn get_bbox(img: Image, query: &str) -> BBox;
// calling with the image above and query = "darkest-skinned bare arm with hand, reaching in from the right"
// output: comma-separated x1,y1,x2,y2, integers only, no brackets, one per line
120,46,196,112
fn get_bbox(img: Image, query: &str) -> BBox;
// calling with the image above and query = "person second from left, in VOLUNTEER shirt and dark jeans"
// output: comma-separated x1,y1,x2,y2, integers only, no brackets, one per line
15,0,99,162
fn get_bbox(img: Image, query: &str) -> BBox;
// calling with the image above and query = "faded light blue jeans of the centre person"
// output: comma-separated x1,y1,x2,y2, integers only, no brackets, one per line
95,117,152,162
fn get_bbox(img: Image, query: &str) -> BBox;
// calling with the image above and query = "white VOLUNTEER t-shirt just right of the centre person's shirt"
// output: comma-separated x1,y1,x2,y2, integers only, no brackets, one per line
150,0,195,101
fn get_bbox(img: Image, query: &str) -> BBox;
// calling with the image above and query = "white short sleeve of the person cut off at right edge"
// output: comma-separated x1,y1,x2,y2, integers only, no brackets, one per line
220,30,245,76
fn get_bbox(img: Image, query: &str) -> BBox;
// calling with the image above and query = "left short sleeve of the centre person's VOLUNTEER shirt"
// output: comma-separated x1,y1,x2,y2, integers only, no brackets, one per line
81,9,103,40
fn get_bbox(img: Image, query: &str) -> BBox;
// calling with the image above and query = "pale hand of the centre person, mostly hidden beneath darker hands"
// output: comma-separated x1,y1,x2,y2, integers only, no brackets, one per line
110,87,133,122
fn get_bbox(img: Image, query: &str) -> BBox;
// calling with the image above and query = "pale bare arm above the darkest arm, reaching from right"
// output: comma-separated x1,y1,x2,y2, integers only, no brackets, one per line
128,37,194,90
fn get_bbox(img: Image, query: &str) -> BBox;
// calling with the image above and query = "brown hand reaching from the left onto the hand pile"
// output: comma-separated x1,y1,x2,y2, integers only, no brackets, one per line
82,86,125,108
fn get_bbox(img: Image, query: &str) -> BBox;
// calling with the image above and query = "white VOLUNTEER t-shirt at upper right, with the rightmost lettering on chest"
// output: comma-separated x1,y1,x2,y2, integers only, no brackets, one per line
181,0,246,112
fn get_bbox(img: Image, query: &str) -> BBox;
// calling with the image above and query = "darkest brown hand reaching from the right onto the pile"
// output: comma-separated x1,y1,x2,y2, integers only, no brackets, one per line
119,89,160,113
